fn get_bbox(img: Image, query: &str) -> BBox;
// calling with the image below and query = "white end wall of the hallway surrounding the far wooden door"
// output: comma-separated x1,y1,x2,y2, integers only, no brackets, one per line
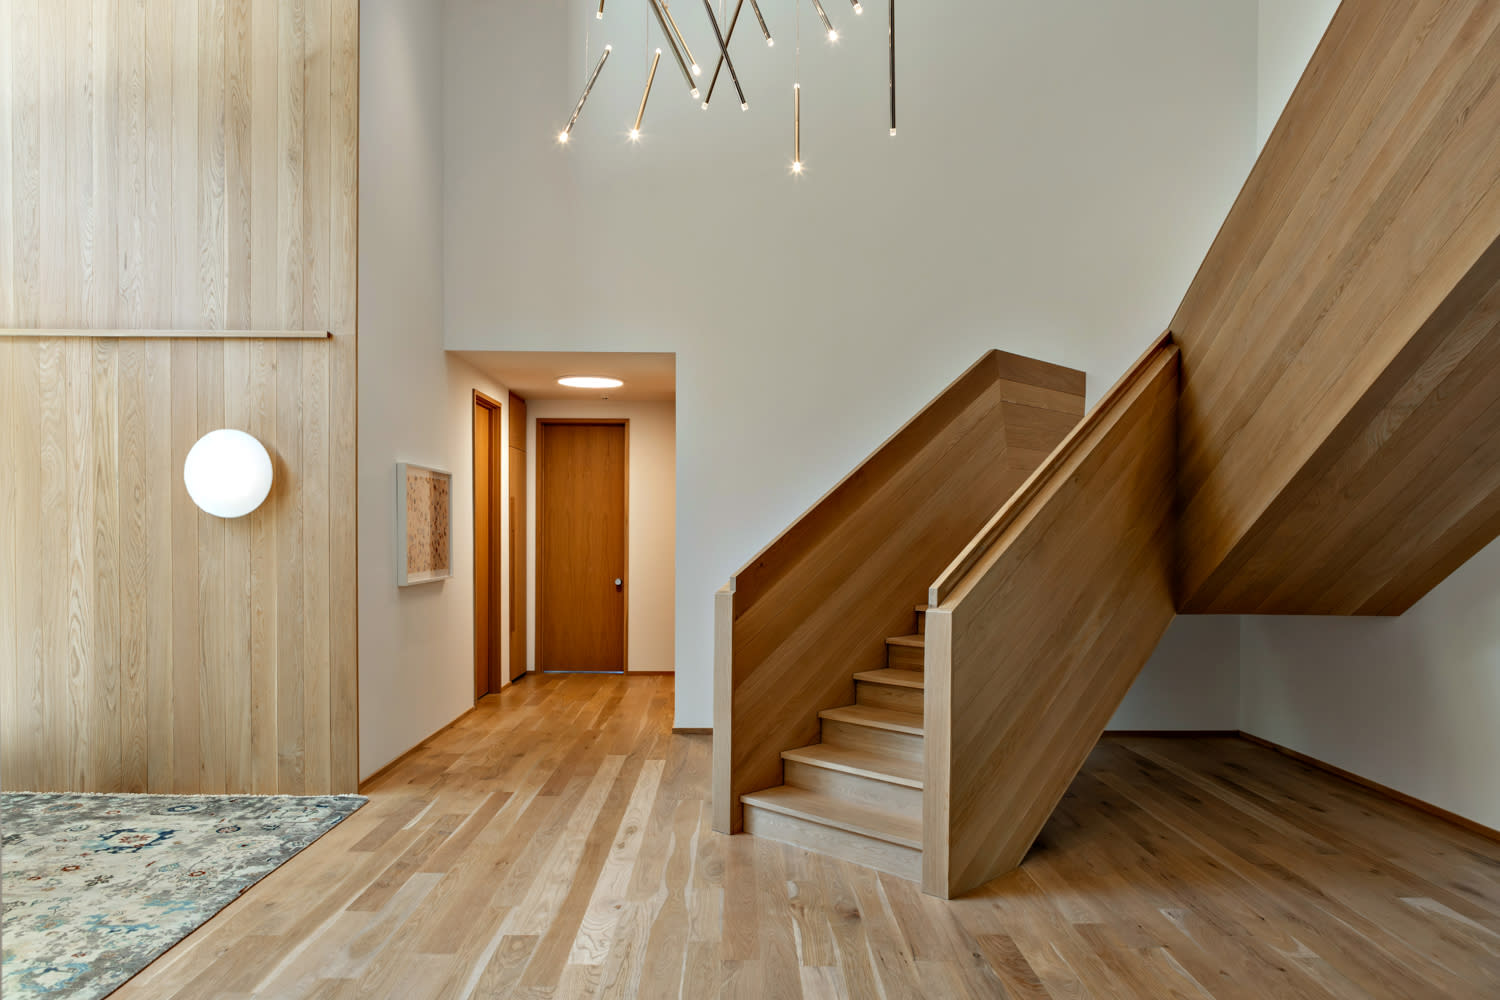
527,399,677,670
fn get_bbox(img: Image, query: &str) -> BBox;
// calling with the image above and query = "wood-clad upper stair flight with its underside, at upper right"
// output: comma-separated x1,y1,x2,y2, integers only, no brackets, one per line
1172,0,1500,615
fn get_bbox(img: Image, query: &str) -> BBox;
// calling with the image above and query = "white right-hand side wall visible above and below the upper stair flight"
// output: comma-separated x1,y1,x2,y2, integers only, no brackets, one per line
1241,0,1500,828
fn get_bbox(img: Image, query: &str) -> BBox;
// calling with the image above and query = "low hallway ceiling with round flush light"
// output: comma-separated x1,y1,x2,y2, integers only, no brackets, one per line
455,351,677,402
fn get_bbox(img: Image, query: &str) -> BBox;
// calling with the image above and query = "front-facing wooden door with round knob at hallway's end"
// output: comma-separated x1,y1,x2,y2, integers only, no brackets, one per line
537,420,627,670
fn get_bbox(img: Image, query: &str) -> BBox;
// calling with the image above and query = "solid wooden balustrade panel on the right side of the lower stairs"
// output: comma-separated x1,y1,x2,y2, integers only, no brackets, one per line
923,339,1178,897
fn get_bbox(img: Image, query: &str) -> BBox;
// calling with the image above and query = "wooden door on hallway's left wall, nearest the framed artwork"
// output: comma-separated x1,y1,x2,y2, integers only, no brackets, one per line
474,393,503,700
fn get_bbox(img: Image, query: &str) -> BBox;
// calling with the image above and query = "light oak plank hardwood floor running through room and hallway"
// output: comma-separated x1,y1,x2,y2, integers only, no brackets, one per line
116,675,1500,1000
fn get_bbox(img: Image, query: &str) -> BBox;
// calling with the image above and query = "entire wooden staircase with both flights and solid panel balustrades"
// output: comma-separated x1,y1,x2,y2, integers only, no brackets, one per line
714,0,1500,897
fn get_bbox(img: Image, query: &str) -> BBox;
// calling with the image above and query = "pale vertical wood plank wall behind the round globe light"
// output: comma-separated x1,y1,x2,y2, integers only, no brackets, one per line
0,0,359,793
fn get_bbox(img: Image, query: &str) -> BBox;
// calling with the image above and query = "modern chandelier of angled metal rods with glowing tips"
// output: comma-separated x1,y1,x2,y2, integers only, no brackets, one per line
558,0,896,174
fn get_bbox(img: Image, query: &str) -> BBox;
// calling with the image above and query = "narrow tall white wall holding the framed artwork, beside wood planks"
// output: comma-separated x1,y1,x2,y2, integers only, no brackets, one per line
359,0,506,778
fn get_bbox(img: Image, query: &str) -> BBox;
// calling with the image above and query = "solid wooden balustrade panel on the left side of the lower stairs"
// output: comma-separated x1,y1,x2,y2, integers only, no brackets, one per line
714,351,1085,832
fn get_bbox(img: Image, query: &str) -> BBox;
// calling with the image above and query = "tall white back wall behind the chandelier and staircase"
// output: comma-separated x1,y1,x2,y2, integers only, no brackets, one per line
441,0,1257,729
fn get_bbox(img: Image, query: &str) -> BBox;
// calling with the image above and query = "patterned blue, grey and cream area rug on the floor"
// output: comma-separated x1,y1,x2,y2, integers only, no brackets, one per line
0,793,366,1000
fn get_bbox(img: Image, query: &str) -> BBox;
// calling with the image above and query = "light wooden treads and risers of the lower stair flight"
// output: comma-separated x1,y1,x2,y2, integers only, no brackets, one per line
741,607,926,882
